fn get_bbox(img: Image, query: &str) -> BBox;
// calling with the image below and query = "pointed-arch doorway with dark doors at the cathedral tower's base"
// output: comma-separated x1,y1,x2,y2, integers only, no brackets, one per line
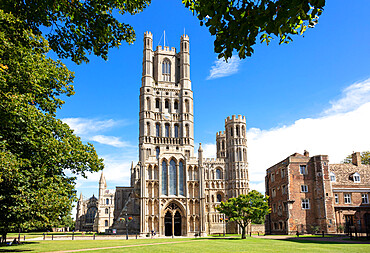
164,203,182,236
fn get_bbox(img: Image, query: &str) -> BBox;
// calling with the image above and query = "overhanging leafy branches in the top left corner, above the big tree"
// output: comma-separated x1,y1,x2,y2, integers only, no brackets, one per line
0,0,151,64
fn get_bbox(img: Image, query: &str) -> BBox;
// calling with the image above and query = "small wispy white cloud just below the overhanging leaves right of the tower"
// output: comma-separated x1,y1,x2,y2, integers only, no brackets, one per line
207,56,240,80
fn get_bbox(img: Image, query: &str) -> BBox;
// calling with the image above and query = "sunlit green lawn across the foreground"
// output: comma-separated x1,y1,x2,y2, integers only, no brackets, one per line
0,238,370,253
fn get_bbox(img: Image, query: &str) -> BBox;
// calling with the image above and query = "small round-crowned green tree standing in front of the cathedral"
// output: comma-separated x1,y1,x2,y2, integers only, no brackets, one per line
216,190,270,239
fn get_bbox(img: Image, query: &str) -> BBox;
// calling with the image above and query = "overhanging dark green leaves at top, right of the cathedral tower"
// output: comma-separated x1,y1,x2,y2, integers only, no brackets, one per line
182,0,325,60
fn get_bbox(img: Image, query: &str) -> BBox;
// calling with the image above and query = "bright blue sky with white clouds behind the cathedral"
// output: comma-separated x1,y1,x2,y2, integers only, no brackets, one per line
57,0,370,208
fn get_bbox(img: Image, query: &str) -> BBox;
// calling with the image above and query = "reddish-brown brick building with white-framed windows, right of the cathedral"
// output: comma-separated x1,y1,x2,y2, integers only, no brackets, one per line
265,151,370,234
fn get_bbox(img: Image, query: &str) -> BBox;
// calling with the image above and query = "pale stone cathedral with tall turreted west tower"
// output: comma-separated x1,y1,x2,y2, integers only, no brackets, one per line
76,32,249,236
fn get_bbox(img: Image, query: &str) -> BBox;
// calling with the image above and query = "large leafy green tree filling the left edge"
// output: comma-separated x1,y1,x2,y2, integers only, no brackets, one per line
0,10,103,242
